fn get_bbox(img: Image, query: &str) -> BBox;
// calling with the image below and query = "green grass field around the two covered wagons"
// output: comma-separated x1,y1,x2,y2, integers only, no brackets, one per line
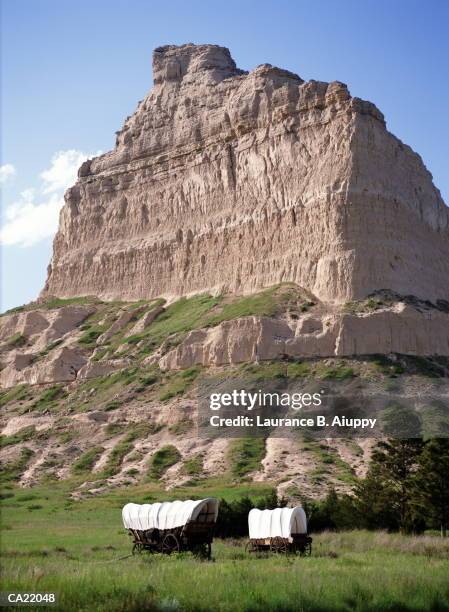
2,485,449,612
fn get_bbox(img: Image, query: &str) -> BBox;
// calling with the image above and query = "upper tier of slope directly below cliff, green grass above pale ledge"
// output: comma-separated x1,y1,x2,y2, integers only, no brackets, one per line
0,283,449,388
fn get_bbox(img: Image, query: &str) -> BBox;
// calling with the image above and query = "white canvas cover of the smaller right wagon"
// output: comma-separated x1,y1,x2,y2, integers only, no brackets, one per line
248,506,307,540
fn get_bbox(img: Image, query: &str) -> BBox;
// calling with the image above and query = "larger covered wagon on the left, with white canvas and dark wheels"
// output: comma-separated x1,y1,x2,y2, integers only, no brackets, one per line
122,497,219,558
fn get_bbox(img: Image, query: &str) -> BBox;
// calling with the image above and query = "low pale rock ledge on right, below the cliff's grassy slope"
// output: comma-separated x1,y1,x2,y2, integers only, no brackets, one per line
159,304,449,370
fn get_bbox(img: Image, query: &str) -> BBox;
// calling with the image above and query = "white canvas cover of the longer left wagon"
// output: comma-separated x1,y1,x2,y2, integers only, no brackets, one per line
122,497,218,531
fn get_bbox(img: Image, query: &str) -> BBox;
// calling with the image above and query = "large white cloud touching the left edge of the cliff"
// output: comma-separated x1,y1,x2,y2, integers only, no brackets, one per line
0,149,99,247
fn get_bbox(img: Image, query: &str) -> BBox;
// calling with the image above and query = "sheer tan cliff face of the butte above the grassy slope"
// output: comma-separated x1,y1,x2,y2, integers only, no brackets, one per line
43,45,449,302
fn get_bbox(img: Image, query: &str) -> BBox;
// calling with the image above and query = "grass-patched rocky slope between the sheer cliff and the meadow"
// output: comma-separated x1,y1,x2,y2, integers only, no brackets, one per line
0,284,449,496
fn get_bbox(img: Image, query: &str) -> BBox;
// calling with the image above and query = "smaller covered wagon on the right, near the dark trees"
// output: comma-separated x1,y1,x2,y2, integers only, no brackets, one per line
247,506,312,555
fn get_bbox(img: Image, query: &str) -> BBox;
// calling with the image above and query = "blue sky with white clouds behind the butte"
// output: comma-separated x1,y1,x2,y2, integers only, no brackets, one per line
0,0,449,311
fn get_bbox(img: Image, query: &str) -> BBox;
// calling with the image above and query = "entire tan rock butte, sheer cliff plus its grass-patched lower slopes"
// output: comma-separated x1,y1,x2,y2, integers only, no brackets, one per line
0,45,449,497
